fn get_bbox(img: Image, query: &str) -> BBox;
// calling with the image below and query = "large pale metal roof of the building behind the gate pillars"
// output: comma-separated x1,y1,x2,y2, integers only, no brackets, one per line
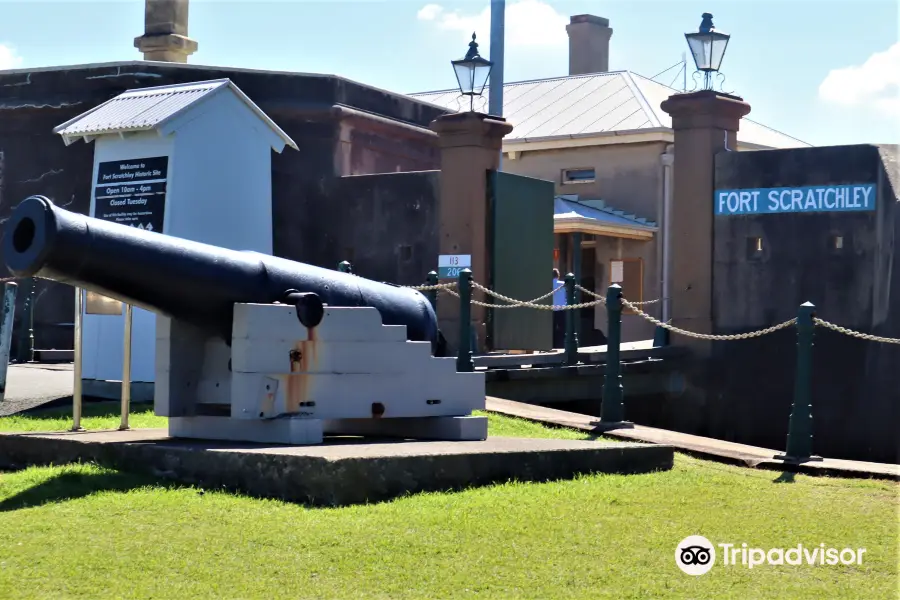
410,71,810,148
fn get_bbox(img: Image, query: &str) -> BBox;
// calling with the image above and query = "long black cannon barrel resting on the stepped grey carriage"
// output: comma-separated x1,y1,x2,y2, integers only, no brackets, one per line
3,196,439,346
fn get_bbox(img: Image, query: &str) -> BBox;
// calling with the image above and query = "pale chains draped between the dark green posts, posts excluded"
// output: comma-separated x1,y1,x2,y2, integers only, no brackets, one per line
406,281,900,345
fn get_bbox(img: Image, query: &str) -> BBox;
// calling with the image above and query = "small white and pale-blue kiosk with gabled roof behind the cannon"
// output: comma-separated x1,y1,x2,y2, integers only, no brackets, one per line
53,79,297,400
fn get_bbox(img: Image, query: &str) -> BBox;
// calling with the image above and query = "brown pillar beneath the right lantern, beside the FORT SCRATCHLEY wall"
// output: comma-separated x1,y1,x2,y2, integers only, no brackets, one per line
661,90,750,352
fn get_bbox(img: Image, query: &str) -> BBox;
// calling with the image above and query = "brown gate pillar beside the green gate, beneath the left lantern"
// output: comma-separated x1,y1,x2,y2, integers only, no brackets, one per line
431,112,513,352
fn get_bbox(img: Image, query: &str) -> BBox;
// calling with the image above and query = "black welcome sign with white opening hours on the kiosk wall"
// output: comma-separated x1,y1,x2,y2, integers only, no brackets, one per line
94,156,169,233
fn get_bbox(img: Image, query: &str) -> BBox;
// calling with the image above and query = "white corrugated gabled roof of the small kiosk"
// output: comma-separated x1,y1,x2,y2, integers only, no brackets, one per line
53,79,297,151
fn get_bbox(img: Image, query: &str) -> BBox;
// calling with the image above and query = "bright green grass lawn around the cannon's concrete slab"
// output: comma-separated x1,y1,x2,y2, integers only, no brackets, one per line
0,406,900,600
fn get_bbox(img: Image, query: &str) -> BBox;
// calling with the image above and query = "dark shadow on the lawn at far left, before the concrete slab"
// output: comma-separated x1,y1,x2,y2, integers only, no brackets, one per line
0,471,182,512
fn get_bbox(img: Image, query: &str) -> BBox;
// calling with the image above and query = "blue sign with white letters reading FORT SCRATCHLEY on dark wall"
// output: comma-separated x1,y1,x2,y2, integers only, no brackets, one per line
714,183,875,215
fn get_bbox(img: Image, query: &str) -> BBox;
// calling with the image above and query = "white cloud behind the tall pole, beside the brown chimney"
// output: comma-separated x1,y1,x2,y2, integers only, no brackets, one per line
418,0,569,49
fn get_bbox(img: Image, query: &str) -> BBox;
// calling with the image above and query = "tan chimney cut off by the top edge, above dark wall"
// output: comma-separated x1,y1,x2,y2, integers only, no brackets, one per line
134,0,197,63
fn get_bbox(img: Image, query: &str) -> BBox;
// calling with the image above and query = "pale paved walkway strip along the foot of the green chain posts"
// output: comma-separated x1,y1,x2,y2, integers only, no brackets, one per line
487,396,900,481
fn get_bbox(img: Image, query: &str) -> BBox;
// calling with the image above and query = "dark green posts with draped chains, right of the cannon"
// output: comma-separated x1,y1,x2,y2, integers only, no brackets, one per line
341,261,900,462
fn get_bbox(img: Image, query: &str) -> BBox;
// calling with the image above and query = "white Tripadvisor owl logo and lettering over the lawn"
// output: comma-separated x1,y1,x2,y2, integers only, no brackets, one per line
675,535,866,575
